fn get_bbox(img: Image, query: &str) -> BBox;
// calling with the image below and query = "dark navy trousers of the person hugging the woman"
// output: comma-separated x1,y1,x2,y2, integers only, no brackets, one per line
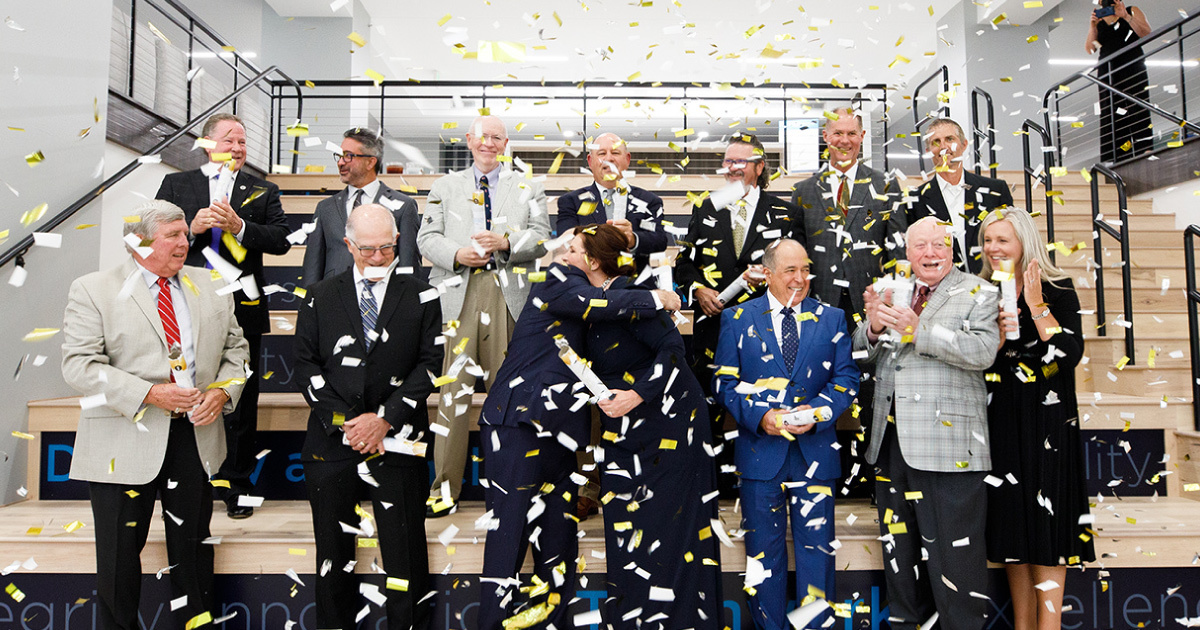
475,425,578,630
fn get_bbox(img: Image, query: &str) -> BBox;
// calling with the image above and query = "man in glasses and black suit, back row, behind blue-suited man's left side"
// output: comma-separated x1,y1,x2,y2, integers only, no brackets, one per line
676,132,800,470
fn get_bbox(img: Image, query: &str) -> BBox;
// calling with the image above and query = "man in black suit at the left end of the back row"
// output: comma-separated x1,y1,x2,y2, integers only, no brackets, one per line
156,114,292,518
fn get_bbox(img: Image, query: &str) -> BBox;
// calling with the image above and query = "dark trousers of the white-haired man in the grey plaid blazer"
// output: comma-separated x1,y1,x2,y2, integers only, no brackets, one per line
875,426,988,630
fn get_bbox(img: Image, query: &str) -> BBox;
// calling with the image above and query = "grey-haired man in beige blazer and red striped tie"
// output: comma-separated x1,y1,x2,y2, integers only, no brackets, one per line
62,200,250,630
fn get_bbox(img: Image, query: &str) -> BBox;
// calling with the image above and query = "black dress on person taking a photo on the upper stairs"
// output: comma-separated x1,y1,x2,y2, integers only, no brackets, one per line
1096,7,1153,162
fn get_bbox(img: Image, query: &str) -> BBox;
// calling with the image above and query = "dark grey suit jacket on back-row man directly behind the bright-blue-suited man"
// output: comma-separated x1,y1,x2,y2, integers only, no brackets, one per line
792,162,908,313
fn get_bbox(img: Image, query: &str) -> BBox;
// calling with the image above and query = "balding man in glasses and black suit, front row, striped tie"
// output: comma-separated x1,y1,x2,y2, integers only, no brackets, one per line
295,204,443,630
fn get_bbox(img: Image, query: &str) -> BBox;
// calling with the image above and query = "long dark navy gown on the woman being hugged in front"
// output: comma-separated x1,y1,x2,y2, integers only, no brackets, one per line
588,278,725,629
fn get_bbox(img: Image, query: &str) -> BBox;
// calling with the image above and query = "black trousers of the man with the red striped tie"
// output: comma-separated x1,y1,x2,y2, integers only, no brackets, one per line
88,419,212,630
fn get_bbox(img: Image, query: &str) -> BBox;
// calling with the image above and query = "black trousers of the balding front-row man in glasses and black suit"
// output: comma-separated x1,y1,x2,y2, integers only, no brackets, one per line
304,455,433,630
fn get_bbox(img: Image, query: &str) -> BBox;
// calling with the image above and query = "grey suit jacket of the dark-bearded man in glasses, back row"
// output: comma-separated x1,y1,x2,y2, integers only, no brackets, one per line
304,181,421,287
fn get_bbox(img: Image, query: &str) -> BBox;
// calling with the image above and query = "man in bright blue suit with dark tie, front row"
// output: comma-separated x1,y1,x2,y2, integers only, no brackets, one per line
713,239,859,630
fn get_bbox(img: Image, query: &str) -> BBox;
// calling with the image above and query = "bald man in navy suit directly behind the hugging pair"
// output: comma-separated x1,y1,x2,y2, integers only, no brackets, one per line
557,133,667,270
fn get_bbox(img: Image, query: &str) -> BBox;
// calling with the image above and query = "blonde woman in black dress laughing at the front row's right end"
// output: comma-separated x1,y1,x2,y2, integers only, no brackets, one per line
979,209,1096,630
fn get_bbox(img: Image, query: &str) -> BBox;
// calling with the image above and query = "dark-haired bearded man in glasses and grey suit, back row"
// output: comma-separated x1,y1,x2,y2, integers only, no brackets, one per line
304,127,421,287
